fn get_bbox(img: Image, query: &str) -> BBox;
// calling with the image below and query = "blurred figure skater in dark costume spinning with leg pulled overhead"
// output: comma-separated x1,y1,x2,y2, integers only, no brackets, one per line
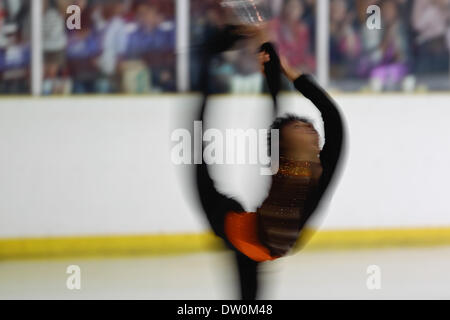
196,26,344,300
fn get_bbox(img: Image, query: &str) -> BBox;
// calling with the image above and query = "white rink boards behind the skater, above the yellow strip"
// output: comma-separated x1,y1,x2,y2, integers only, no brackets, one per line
0,94,450,238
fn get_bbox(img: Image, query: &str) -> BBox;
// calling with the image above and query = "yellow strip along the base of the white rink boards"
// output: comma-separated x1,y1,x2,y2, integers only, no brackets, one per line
0,227,450,260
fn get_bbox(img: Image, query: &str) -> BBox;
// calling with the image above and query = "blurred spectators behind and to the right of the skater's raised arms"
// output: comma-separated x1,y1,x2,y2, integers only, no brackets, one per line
191,0,450,92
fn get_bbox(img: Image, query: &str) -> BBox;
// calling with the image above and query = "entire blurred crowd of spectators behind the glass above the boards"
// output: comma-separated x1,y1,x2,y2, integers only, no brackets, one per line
0,0,450,94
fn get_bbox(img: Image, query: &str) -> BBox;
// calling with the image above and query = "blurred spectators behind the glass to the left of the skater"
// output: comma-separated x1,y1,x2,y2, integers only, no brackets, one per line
0,0,176,94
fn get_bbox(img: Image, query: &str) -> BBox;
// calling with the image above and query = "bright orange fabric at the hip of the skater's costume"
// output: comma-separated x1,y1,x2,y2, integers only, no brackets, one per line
225,212,280,262
